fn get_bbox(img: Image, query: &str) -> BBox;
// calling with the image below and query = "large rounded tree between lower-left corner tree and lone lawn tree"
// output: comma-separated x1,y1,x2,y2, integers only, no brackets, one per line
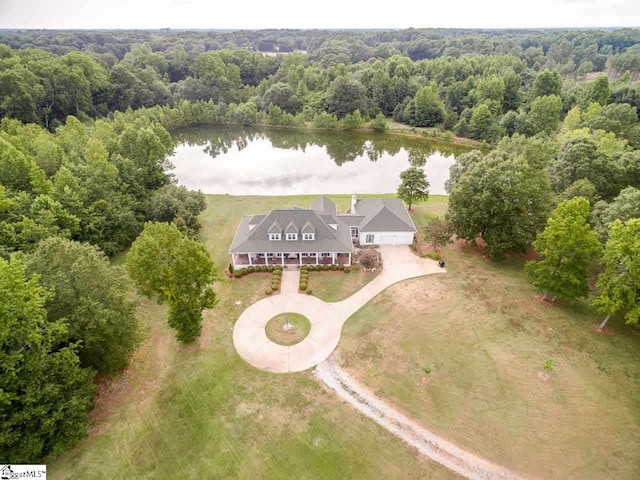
25,237,140,374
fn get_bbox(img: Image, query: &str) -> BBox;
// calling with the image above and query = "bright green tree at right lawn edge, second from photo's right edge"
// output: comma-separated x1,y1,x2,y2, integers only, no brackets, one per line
525,197,602,300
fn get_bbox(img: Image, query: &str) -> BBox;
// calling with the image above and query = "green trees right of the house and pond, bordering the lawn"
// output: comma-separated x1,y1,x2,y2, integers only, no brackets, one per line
418,127,640,328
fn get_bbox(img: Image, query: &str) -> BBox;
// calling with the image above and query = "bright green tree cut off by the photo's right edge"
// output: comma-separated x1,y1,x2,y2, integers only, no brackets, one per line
592,218,640,329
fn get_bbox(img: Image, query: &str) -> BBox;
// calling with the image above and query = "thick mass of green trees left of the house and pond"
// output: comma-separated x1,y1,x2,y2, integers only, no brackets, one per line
0,108,216,463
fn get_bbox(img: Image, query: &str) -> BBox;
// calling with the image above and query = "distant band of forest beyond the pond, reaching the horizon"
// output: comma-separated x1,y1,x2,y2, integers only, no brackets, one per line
0,30,640,143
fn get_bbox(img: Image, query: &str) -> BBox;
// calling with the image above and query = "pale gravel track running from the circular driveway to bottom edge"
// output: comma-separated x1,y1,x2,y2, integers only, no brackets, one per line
313,358,524,480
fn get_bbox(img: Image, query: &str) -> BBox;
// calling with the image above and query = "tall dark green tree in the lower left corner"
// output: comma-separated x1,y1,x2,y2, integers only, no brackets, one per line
0,256,95,463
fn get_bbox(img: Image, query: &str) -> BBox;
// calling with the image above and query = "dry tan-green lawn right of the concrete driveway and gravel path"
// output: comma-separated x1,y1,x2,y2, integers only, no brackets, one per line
338,209,640,479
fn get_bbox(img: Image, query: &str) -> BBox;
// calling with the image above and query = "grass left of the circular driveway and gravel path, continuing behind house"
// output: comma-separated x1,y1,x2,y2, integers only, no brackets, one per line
48,195,455,479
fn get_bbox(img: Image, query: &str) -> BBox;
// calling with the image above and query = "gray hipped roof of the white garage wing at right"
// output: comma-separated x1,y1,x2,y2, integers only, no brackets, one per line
356,198,416,232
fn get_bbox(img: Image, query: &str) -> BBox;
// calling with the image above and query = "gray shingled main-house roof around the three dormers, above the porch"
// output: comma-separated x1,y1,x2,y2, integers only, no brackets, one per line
229,209,353,253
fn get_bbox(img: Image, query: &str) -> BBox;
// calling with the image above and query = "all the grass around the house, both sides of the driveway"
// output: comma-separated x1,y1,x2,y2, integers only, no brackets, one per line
48,195,640,479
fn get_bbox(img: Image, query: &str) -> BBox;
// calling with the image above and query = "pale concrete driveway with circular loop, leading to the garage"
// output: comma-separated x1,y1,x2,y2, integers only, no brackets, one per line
233,245,446,373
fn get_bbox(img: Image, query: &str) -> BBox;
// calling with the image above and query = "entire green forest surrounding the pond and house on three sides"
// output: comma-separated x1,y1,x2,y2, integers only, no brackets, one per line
0,29,640,463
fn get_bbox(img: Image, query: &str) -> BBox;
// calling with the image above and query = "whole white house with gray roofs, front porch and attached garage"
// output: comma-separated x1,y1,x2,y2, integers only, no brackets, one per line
229,195,416,269
